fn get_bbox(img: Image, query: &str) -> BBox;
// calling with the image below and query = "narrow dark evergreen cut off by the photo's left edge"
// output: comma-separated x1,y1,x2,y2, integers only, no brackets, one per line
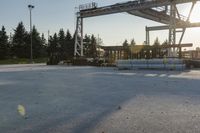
0,26,9,59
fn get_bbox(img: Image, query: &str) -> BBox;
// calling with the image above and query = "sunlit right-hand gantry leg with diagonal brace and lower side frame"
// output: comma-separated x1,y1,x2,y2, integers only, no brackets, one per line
146,1,197,57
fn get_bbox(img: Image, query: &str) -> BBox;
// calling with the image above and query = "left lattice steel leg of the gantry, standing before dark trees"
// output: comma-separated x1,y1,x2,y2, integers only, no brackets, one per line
74,16,83,57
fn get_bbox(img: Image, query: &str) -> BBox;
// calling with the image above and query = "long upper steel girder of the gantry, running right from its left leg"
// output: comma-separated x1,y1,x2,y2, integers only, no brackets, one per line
79,0,200,18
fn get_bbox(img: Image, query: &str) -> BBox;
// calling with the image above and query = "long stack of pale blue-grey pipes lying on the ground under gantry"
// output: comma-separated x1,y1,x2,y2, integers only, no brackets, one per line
116,58,186,70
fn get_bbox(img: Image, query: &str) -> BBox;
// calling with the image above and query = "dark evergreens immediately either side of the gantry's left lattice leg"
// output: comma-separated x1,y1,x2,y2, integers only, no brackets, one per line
47,29,97,64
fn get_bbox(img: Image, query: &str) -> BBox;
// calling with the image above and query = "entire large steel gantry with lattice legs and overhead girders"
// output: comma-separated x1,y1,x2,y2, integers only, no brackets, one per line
74,0,200,57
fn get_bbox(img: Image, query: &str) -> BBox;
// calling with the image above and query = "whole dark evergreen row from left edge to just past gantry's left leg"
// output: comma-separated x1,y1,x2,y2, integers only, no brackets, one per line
0,22,97,61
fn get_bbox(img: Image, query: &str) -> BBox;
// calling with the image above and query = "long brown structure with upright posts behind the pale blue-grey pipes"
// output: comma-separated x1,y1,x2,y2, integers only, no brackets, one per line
101,45,167,62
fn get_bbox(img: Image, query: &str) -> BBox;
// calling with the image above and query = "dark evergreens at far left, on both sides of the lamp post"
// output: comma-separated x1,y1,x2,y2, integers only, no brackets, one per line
0,22,47,59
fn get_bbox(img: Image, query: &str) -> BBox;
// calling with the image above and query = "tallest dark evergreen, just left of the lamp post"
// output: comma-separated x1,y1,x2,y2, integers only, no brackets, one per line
12,22,30,58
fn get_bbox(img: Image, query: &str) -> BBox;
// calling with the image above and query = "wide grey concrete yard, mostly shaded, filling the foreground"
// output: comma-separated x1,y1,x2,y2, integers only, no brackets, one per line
0,64,200,133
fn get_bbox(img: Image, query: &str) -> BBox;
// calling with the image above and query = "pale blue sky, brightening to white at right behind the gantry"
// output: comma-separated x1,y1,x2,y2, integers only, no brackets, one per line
0,0,200,49
